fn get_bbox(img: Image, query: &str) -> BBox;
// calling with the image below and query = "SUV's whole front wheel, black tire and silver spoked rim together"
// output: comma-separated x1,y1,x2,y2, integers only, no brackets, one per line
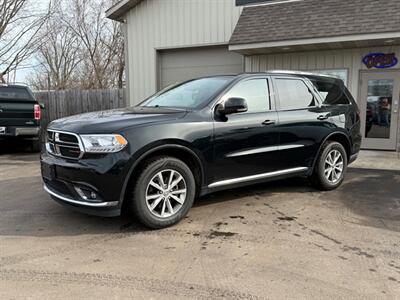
127,156,196,229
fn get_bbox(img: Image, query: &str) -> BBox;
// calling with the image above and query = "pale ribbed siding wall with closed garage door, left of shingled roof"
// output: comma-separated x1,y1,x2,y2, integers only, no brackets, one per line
109,0,243,104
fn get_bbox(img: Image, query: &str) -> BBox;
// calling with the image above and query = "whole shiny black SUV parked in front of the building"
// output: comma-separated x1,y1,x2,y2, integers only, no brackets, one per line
41,71,361,228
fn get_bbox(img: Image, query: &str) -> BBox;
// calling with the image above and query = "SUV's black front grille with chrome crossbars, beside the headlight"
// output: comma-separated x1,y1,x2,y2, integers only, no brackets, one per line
46,130,83,159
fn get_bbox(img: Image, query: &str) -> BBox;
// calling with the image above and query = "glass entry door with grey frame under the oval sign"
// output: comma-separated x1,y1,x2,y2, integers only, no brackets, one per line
360,71,400,150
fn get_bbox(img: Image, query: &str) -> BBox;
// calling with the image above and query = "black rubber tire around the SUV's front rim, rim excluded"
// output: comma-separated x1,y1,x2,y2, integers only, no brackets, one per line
132,158,196,229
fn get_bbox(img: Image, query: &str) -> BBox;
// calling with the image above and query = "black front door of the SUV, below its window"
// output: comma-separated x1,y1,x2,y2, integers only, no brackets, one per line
213,112,279,181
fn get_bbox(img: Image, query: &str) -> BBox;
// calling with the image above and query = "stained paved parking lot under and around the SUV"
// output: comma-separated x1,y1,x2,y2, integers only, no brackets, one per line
0,150,400,299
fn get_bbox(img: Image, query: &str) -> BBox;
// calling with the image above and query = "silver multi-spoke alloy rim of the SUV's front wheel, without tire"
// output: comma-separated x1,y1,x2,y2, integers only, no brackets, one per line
146,169,187,218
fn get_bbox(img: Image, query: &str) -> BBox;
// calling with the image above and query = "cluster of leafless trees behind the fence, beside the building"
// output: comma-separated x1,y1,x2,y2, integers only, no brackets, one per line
30,0,125,89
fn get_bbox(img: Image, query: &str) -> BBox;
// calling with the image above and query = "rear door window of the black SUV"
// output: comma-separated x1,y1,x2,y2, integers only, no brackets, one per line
275,78,316,110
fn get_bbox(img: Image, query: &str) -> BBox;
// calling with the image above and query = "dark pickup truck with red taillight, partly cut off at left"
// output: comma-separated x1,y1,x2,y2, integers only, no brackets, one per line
0,85,43,152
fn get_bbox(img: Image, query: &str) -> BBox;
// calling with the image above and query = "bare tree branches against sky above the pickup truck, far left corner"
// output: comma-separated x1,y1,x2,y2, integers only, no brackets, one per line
0,0,49,83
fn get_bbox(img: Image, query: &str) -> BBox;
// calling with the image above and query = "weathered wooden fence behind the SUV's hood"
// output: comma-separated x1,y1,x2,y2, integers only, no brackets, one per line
34,89,127,128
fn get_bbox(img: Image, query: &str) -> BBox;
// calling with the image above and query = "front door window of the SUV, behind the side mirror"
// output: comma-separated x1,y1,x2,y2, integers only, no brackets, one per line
224,79,271,113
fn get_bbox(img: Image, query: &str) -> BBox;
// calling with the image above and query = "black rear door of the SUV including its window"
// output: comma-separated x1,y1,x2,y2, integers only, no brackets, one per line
273,76,330,169
